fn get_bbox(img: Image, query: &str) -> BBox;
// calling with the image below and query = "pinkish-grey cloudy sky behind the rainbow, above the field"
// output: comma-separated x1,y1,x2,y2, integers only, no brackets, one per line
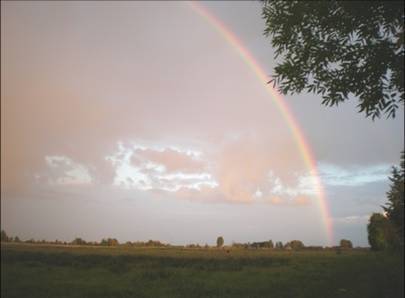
1,1,404,246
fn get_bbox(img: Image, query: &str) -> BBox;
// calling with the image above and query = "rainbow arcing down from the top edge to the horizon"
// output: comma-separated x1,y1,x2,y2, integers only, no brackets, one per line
186,1,333,245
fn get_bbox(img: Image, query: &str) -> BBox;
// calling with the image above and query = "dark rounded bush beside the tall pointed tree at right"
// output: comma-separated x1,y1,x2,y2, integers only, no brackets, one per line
367,213,399,250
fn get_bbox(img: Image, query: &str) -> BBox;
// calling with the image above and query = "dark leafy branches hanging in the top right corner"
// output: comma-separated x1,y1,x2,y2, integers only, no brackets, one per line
262,0,404,119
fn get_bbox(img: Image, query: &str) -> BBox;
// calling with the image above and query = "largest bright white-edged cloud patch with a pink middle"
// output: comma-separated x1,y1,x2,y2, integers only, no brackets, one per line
106,142,218,192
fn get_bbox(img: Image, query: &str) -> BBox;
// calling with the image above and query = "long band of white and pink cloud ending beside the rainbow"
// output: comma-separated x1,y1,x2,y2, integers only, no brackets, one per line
99,139,317,206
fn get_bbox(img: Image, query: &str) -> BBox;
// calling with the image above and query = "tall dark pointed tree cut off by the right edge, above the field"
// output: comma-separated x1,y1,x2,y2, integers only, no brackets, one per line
383,151,405,246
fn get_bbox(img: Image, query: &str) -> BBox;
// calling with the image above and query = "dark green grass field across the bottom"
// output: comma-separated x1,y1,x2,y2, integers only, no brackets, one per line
1,244,404,298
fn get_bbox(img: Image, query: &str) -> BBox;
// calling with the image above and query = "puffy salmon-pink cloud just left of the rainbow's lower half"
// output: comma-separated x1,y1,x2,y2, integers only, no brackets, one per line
214,134,305,202
